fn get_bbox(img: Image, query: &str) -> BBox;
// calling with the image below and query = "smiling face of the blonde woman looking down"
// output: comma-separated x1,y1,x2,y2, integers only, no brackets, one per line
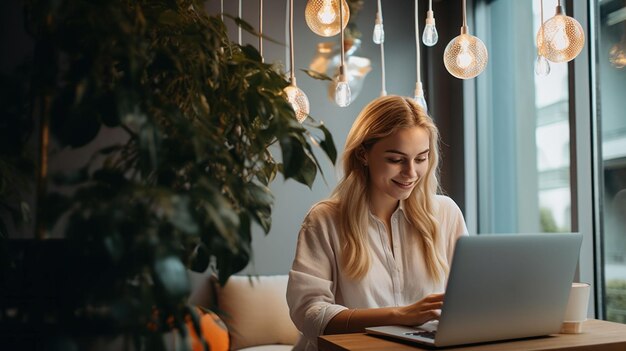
363,127,430,214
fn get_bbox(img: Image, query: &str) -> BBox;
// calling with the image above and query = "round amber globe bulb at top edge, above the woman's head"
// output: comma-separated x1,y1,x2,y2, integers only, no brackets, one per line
304,0,350,37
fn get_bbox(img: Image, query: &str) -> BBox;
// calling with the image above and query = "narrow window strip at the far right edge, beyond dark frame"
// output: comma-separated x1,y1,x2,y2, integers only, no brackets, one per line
596,0,626,323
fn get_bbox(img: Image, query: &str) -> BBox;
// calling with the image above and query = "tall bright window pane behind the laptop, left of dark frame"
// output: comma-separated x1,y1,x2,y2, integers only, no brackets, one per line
476,0,572,233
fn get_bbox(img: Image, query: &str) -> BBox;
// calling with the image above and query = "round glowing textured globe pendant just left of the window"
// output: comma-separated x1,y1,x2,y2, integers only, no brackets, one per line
443,0,489,79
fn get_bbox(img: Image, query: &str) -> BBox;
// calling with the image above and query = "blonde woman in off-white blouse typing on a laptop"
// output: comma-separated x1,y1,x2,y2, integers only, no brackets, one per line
287,96,467,350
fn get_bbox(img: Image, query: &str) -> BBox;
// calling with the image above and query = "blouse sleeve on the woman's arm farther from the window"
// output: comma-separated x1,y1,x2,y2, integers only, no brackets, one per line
287,205,347,343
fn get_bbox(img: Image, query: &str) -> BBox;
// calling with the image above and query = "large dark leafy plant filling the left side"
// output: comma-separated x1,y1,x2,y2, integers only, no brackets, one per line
0,0,336,347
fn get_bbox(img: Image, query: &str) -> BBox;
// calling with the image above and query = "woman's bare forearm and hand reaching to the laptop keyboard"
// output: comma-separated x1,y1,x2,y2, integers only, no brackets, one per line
324,294,444,334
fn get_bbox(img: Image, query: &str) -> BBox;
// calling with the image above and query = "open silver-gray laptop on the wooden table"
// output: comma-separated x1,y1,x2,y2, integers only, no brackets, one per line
365,233,582,347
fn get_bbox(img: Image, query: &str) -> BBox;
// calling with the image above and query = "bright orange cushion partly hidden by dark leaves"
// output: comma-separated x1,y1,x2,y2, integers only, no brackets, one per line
187,308,230,351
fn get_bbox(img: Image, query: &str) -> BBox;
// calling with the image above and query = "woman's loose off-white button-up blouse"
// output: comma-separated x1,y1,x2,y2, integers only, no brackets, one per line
287,195,467,350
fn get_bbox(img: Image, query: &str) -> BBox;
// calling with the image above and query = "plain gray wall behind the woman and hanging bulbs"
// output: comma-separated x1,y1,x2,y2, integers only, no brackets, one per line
207,0,463,274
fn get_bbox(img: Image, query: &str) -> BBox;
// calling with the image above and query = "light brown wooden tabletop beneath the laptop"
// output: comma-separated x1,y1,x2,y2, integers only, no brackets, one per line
318,319,626,351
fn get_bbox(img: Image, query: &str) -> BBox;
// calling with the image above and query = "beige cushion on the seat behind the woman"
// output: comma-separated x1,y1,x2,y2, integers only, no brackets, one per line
217,275,300,350
